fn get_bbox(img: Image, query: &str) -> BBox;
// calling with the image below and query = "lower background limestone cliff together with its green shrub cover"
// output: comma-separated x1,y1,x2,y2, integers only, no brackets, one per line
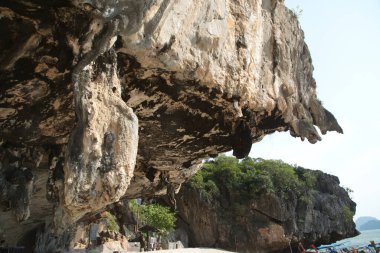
176,158,358,253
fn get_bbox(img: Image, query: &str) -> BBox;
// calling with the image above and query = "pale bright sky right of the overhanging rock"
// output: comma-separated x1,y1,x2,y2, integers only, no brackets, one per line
250,0,380,219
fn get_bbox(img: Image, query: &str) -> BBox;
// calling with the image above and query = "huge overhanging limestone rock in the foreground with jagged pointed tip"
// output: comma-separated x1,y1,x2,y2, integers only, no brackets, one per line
0,0,342,249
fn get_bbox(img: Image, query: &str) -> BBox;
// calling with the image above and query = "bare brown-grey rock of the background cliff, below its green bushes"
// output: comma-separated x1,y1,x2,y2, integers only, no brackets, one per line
177,168,358,252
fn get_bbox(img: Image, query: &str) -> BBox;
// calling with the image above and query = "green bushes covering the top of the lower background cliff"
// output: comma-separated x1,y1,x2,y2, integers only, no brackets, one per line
187,155,321,203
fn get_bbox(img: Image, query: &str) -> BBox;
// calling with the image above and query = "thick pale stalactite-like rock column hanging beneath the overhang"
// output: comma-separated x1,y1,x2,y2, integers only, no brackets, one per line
62,52,138,221
